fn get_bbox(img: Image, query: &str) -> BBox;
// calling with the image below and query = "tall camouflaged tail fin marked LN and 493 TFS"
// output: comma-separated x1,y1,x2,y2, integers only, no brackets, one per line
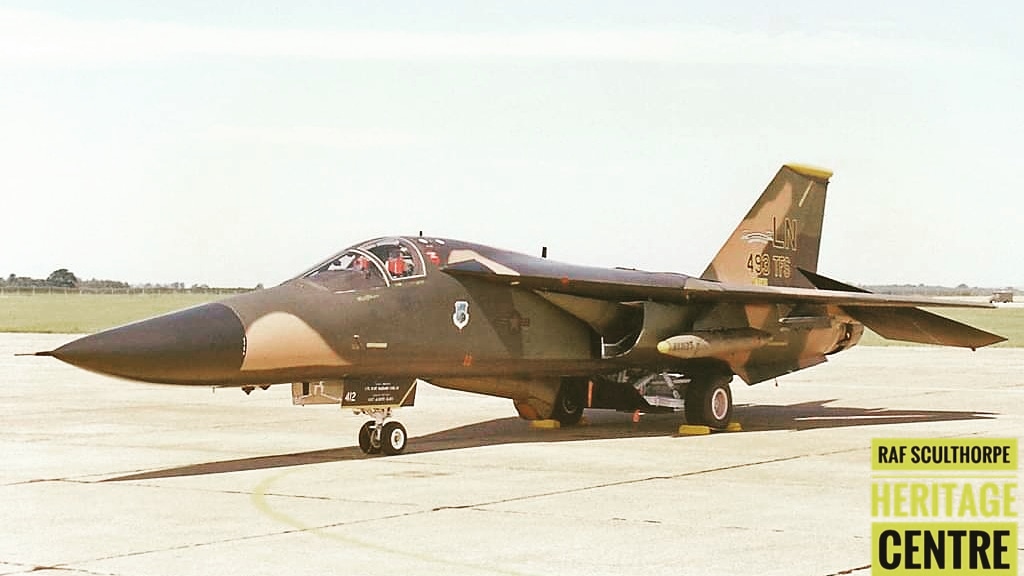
700,164,831,288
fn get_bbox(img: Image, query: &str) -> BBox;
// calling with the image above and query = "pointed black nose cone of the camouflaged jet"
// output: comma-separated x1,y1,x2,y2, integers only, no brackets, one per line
48,297,245,384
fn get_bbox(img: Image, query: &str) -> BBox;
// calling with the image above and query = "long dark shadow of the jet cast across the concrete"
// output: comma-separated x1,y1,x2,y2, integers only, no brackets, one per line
102,400,995,482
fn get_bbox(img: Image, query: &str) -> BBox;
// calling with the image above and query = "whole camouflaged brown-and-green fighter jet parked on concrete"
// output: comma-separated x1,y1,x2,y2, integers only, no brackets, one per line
37,164,1005,454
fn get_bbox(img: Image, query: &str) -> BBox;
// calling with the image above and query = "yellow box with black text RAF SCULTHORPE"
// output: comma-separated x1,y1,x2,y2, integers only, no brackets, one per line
871,438,1019,471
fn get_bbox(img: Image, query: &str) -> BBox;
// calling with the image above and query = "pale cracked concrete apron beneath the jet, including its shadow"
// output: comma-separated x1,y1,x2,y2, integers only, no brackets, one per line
0,334,1024,576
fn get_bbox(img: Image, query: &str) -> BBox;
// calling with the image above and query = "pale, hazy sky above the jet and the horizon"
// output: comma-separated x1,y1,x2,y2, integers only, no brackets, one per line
0,1,1024,286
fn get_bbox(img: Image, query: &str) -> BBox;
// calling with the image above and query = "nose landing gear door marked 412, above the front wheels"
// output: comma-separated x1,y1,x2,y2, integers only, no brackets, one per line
292,379,417,410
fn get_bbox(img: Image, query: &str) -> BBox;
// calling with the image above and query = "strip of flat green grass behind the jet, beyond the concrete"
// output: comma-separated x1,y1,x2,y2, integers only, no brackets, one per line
0,293,1024,347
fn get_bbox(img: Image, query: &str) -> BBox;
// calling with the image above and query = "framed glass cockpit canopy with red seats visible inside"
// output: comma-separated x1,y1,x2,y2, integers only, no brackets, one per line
300,238,426,292
